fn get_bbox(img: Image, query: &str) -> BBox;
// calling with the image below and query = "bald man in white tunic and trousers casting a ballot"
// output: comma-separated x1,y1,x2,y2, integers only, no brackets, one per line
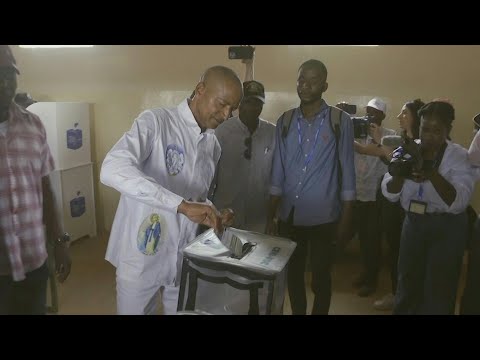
100,66,243,314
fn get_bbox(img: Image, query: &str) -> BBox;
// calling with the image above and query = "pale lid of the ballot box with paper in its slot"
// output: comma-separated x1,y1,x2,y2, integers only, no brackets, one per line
183,227,297,275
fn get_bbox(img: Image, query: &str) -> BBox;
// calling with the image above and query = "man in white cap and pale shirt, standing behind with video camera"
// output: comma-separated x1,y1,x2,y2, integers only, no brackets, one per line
353,98,396,296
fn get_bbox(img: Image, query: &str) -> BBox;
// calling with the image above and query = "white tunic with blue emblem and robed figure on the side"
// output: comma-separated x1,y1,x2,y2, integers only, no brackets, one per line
100,100,220,285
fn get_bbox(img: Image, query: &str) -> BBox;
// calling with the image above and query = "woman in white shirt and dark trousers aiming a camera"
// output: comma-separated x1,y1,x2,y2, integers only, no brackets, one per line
382,101,474,314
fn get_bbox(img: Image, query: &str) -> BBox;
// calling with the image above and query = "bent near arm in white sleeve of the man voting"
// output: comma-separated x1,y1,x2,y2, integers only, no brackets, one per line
100,111,183,213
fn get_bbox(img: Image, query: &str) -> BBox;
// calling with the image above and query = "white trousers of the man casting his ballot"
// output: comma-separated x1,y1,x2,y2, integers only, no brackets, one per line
117,276,180,315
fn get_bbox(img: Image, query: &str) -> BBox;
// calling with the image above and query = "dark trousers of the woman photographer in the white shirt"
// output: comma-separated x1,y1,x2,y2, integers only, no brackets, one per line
393,213,467,315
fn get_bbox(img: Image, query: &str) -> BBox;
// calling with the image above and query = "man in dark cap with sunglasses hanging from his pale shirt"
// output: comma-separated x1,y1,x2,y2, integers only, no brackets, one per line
212,80,275,232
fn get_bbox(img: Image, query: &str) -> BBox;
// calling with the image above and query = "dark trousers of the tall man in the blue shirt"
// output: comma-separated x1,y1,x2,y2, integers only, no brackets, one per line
278,217,336,315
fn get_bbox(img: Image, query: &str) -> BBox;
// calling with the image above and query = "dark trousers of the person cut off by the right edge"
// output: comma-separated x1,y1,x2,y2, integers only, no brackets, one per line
460,219,480,315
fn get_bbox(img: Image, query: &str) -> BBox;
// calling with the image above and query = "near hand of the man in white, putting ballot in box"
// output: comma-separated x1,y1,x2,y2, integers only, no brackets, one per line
177,200,223,233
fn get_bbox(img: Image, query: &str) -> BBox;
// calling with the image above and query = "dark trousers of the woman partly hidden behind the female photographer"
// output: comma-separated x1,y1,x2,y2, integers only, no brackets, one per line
380,195,405,294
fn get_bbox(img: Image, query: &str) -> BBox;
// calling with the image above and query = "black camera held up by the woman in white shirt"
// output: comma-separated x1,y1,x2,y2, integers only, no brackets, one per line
388,138,423,177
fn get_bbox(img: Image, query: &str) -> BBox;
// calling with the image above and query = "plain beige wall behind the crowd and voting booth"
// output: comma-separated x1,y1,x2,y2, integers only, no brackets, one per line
12,45,480,229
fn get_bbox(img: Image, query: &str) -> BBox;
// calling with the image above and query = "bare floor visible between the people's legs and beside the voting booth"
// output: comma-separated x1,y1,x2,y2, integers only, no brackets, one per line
51,236,464,315
